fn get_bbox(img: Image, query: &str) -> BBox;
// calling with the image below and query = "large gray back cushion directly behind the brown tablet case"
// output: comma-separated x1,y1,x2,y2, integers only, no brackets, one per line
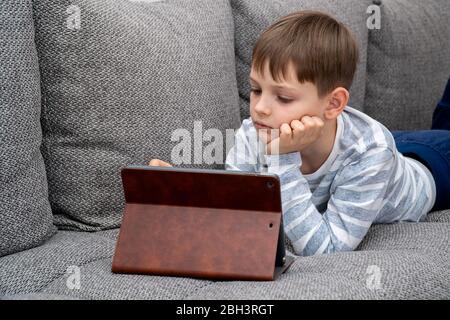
34,0,240,231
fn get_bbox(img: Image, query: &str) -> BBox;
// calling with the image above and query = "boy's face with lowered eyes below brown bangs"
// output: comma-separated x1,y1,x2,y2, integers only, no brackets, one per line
250,63,327,130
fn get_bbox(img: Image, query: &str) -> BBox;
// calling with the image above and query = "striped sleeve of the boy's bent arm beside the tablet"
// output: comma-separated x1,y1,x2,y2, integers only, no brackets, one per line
266,147,395,256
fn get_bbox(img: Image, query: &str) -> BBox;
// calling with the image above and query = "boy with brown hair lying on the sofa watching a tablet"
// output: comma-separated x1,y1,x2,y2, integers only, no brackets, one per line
150,11,450,256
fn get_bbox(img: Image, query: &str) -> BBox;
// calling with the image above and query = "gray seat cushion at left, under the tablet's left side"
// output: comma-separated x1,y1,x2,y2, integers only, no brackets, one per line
0,229,211,299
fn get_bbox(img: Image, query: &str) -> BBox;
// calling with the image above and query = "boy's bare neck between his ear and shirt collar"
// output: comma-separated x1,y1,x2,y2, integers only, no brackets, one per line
300,119,337,174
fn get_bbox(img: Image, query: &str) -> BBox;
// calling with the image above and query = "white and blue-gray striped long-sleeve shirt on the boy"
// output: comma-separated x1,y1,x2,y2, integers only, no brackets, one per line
225,106,436,256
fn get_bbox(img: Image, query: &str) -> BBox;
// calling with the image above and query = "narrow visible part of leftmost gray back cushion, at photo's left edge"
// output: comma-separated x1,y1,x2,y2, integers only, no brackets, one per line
0,0,55,256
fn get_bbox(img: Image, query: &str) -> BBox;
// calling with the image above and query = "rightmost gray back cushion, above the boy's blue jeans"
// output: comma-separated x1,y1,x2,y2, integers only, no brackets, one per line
364,0,450,130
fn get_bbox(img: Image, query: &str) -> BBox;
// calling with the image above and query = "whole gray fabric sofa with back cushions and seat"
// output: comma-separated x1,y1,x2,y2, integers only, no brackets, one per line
0,0,450,299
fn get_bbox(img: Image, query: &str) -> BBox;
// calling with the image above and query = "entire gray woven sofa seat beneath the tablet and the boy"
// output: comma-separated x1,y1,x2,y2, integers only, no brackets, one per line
0,210,450,299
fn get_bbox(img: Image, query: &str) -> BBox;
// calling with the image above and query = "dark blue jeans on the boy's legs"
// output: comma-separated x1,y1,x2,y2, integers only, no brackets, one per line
392,79,450,211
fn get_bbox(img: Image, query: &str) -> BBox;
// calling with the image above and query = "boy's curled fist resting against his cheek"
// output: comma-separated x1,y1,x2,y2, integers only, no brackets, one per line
266,116,325,154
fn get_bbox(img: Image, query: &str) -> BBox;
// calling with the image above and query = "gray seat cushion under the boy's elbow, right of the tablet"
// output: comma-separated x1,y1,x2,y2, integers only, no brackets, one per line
186,250,450,300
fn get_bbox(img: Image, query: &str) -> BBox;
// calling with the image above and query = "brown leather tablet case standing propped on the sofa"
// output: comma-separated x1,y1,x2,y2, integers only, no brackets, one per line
112,166,293,280
